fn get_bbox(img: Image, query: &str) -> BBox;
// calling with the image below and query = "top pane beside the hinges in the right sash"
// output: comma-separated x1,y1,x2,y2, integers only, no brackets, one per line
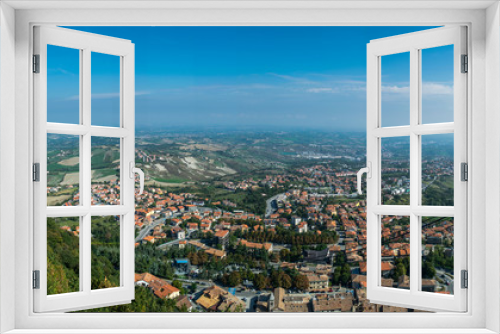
422,45,454,123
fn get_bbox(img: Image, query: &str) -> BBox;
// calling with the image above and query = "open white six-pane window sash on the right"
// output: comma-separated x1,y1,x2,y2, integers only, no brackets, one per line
367,26,471,312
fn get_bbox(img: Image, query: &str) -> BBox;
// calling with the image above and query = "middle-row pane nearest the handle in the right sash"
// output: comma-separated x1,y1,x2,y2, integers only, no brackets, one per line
381,137,410,205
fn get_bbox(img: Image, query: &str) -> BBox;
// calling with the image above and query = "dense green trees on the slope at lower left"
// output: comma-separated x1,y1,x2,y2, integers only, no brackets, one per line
47,216,187,312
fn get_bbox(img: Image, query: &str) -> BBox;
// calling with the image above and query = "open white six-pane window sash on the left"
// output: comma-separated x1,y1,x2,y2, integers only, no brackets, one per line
33,26,135,312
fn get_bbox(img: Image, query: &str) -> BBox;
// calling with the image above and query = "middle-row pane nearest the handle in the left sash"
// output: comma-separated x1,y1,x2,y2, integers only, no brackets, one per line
91,137,120,205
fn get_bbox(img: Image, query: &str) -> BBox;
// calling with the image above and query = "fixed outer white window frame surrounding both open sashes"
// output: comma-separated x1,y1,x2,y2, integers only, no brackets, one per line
0,1,500,333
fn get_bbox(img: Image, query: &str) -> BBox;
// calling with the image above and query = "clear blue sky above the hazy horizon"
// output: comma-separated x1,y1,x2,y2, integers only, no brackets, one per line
48,27,453,131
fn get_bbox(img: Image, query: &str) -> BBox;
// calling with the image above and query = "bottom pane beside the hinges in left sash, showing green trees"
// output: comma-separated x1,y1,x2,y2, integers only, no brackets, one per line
47,217,80,295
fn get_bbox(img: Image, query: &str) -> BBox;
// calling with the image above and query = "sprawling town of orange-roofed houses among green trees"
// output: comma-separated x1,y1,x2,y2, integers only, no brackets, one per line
47,131,453,312
